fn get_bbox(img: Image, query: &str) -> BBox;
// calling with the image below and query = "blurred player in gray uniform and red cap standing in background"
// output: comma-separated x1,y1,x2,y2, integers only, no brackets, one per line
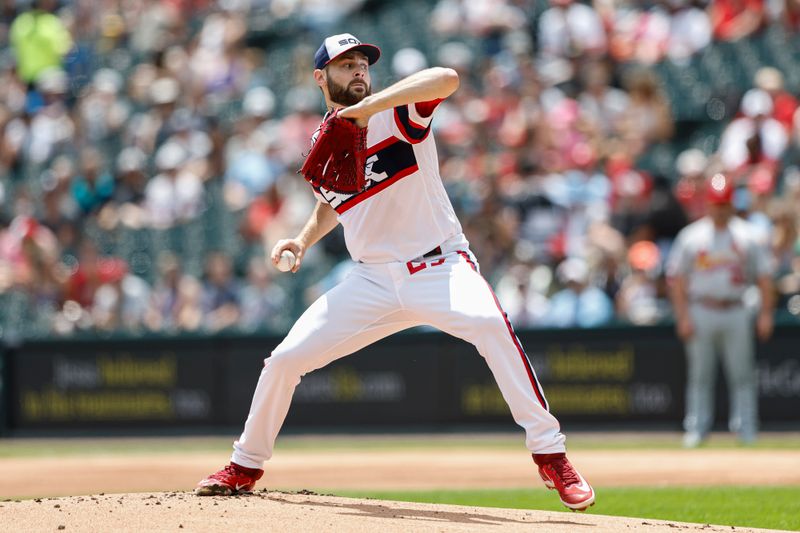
667,174,773,448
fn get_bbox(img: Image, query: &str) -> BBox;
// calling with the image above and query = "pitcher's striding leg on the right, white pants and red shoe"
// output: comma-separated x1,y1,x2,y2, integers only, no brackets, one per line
402,251,594,511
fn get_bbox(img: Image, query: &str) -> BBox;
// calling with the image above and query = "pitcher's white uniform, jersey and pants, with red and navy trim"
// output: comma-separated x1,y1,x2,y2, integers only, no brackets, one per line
232,101,565,468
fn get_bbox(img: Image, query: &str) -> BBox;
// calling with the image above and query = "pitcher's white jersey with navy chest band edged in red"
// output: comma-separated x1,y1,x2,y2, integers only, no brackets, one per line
314,100,462,263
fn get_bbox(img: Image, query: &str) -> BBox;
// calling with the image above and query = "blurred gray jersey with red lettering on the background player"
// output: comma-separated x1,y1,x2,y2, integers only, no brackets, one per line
667,217,772,300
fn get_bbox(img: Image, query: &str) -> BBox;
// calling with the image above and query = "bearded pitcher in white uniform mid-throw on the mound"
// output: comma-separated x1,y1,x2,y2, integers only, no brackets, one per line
196,34,595,510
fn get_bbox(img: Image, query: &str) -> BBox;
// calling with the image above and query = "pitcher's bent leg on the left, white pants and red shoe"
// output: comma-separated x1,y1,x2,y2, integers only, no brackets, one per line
196,267,419,495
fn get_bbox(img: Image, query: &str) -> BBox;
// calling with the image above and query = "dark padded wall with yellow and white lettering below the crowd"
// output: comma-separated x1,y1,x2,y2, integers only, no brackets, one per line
0,326,800,434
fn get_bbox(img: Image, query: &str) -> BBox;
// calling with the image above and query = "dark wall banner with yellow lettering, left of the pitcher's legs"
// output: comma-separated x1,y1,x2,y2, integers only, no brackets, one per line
10,341,225,430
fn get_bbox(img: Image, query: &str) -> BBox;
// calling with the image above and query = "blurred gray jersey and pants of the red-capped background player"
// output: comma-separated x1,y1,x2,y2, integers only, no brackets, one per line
667,217,771,441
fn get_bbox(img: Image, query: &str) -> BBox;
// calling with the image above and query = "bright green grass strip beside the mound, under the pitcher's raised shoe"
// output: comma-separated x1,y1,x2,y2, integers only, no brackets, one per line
336,487,800,531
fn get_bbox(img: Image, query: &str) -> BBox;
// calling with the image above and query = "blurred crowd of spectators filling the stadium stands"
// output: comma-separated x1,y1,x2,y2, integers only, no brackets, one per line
0,0,800,335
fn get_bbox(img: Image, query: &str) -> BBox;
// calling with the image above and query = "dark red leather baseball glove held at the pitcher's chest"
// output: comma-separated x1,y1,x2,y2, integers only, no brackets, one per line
300,109,367,194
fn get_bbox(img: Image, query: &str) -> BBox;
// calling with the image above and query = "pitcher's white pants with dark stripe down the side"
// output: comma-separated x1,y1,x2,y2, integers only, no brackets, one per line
231,237,565,468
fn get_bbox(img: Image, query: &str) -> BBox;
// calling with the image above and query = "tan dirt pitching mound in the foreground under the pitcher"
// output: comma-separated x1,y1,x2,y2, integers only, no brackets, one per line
0,491,784,533
